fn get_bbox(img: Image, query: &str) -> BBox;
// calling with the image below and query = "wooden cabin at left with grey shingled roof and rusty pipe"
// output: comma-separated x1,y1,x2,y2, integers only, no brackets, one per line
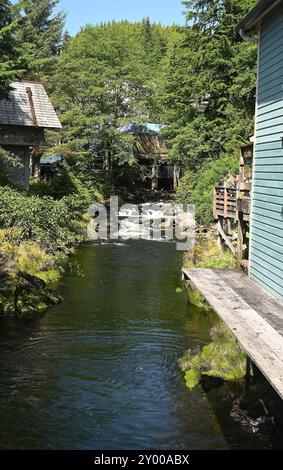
0,80,62,190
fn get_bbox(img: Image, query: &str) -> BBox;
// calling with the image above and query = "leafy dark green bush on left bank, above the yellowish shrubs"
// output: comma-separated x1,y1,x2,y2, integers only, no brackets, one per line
0,187,87,253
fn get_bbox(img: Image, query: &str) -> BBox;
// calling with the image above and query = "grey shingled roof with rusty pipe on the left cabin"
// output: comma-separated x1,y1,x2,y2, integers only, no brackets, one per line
0,80,62,129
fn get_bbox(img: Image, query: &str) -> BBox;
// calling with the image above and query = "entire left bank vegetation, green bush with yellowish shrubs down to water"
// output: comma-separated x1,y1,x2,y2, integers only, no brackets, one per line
0,182,89,317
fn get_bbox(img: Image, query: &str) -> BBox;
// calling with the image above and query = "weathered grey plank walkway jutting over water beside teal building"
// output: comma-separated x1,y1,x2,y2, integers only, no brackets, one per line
183,269,283,399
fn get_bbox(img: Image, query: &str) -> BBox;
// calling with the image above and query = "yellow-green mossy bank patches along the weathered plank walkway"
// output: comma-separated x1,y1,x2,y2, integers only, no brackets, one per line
182,233,247,390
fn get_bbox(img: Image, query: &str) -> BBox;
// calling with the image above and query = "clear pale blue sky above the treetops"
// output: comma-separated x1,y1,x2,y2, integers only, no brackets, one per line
56,0,187,35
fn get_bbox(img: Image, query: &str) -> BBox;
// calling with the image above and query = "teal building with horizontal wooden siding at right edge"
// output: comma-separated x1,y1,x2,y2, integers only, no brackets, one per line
238,0,283,299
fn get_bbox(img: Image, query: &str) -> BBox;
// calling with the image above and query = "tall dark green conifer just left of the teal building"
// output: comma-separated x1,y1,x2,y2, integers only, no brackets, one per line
161,0,256,171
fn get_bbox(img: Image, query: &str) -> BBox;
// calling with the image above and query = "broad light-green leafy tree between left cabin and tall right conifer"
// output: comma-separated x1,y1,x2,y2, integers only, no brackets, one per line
49,19,178,184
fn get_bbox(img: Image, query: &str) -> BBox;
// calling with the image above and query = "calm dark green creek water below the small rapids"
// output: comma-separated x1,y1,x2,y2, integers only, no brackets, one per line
0,241,280,450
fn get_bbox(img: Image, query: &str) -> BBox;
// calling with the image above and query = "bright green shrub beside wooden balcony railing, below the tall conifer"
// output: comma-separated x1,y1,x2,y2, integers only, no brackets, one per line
177,155,239,226
